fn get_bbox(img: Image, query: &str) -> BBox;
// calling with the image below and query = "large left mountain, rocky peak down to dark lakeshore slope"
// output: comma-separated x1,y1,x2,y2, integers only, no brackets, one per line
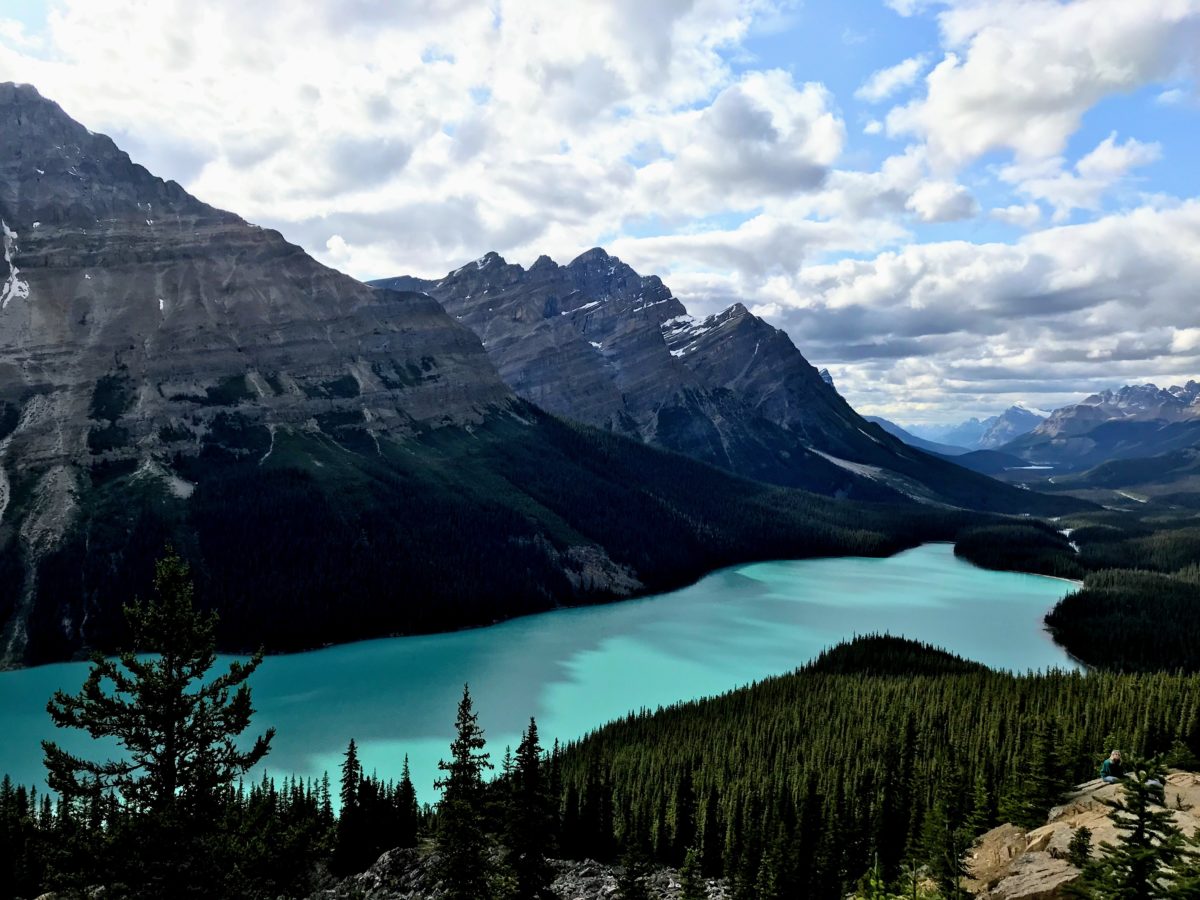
0,84,1022,666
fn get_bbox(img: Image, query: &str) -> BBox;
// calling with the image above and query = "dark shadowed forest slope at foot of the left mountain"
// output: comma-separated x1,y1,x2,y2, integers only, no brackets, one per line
18,406,986,664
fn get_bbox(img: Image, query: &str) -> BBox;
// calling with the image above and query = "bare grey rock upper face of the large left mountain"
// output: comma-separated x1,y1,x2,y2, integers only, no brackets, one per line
0,84,514,665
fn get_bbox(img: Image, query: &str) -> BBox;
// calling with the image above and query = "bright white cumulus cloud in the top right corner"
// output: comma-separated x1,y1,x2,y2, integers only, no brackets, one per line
887,0,1200,167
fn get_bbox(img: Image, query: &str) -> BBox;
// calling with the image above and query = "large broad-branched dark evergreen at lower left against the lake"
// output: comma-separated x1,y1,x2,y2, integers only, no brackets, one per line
42,547,275,896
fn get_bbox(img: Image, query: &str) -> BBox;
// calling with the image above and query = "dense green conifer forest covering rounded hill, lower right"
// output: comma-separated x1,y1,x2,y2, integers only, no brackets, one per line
560,638,1200,900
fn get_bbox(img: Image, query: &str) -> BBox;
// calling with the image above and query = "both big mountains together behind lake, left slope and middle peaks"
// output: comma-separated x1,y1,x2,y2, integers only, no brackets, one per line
0,84,1078,666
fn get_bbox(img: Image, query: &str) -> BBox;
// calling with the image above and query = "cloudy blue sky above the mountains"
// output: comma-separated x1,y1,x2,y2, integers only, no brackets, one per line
0,0,1200,422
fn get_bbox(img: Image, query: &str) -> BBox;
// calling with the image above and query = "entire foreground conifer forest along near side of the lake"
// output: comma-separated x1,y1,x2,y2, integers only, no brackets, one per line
7,636,1200,900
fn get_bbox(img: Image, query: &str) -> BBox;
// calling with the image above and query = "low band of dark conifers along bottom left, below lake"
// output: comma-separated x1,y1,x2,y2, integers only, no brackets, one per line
0,772,432,900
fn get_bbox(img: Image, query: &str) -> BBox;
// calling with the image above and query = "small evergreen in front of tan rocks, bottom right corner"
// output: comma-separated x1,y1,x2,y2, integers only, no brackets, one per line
1076,762,1188,900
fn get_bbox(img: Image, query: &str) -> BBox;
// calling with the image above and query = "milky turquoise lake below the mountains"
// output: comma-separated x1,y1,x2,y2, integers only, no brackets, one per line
0,544,1075,802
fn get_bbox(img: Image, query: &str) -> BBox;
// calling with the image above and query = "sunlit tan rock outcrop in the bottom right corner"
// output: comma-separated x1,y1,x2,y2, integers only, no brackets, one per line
966,772,1200,900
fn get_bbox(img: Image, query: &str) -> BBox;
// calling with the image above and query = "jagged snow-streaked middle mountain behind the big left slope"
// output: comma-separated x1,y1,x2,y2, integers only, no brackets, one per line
373,254,1084,512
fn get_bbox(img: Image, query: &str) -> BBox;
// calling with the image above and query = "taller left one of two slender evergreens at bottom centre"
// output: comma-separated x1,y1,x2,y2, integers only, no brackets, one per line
436,685,492,900
